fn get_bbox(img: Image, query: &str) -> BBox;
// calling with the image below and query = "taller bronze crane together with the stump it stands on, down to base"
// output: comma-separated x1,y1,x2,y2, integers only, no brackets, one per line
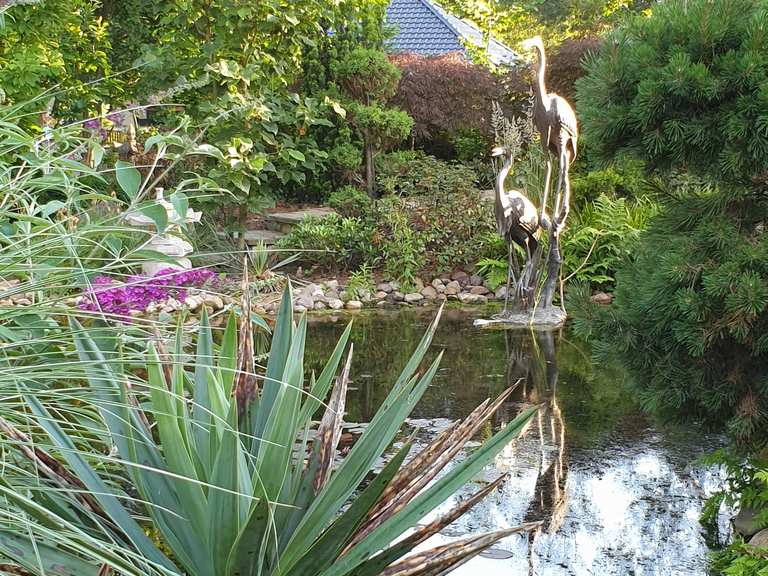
523,36,579,308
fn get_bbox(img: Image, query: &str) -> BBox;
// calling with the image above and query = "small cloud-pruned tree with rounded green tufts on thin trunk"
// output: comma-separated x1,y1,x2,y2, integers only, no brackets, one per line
334,48,413,197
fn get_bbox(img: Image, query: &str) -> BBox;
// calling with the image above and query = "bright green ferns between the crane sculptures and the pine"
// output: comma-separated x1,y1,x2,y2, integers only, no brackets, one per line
562,195,659,287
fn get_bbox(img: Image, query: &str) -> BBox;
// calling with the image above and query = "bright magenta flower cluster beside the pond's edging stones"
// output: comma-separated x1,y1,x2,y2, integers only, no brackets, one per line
80,268,216,316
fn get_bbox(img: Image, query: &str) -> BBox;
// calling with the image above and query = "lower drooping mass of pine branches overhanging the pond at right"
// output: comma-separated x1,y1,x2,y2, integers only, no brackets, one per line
576,177,768,443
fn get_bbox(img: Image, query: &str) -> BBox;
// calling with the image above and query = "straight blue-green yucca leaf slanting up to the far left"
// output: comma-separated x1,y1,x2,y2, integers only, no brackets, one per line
26,396,174,569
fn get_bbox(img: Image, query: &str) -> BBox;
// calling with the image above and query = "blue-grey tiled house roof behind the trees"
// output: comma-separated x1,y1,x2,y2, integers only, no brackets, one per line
387,0,519,65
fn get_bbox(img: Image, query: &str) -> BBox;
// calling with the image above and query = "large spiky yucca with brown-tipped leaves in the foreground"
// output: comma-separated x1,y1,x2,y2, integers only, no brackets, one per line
0,287,536,576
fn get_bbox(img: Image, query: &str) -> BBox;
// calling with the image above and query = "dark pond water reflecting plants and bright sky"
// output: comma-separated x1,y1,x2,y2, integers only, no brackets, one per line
307,309,723,576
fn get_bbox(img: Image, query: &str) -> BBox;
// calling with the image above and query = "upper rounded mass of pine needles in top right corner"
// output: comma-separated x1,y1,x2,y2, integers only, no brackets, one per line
578,0,768,183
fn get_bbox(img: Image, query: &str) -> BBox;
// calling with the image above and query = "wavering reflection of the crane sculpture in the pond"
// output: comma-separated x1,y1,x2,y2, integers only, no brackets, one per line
505,330,568,573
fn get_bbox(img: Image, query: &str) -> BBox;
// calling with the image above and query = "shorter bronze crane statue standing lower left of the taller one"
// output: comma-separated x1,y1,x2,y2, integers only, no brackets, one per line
491,146,549,312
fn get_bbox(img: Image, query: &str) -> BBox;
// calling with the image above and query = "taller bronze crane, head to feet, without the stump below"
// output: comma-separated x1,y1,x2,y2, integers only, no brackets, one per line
523,36,579,232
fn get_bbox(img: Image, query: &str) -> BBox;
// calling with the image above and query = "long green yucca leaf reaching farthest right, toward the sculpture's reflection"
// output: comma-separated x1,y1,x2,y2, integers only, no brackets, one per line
321,407,538,576
